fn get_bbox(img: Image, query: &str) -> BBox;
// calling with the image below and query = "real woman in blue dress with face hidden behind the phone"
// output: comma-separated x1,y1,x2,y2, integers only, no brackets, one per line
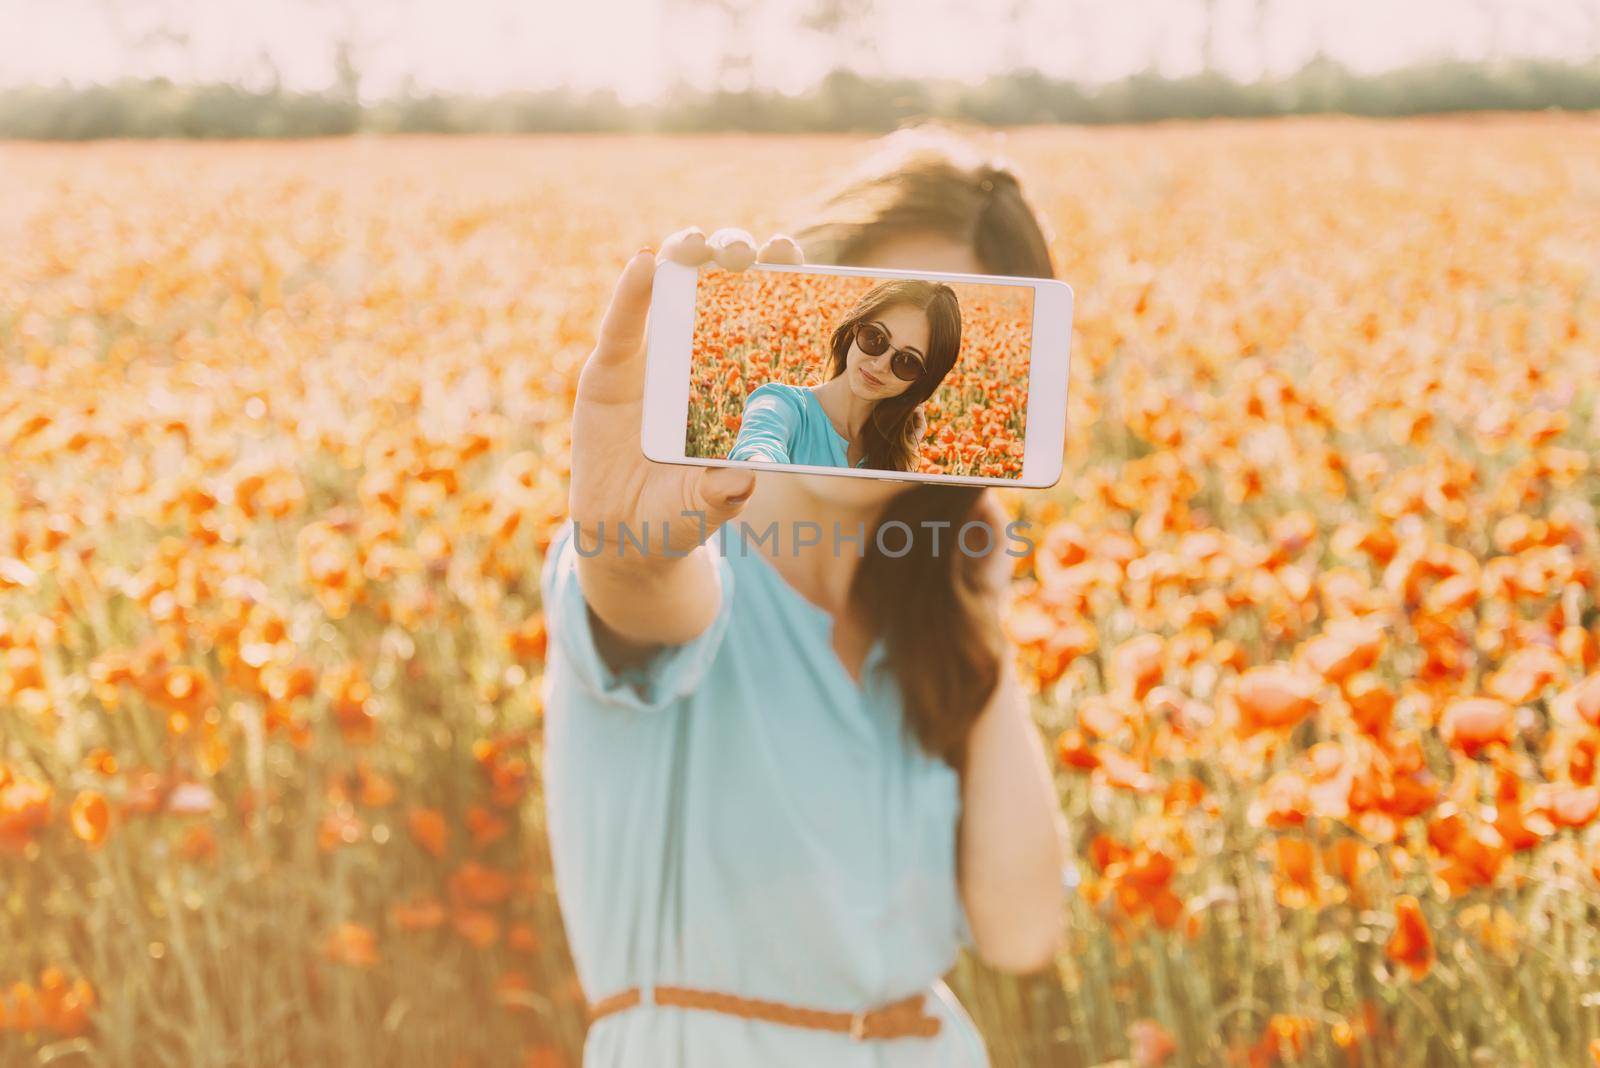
542,120,1064,1068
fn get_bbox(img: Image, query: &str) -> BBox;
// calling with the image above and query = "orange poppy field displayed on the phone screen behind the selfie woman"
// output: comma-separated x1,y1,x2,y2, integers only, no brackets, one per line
685,269,1034,478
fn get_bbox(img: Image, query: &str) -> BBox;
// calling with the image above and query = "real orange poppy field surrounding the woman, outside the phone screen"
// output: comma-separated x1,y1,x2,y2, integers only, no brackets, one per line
0,115,1600,1068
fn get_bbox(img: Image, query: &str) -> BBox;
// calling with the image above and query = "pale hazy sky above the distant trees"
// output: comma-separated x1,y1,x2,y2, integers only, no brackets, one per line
0,0,1600,102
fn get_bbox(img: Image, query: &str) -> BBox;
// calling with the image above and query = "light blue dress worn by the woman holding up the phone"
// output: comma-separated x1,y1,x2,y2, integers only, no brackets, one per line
541,511,989,1068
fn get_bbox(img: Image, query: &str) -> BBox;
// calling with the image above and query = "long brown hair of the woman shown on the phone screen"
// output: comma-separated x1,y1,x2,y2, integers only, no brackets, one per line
827,278,962,472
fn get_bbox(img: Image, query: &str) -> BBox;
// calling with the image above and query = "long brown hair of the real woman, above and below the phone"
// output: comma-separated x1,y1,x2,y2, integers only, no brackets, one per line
790,123,1054,772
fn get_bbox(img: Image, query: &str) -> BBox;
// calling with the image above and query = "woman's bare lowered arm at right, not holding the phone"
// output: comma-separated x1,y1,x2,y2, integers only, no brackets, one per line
957,500,1067,972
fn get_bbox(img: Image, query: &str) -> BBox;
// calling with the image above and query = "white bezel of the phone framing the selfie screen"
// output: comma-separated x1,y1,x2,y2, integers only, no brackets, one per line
640,261,1074,489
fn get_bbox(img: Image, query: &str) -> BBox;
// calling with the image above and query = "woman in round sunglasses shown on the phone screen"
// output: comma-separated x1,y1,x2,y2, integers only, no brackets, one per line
728,278,962,472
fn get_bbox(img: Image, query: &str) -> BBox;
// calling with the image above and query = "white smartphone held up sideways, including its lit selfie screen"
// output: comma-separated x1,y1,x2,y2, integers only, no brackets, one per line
640,261,1072,488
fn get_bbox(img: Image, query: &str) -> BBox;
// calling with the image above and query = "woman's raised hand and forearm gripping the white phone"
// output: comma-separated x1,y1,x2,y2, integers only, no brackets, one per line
568,227,803,644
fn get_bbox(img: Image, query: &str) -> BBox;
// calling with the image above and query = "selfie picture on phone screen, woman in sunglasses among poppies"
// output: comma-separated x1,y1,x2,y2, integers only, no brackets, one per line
685,270,1034,478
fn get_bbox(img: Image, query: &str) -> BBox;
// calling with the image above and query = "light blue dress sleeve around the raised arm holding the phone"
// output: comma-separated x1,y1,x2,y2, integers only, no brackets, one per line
539,521,733,711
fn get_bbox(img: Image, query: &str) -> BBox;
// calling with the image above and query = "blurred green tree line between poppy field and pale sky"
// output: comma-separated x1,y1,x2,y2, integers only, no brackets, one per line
0,56,1600,141
